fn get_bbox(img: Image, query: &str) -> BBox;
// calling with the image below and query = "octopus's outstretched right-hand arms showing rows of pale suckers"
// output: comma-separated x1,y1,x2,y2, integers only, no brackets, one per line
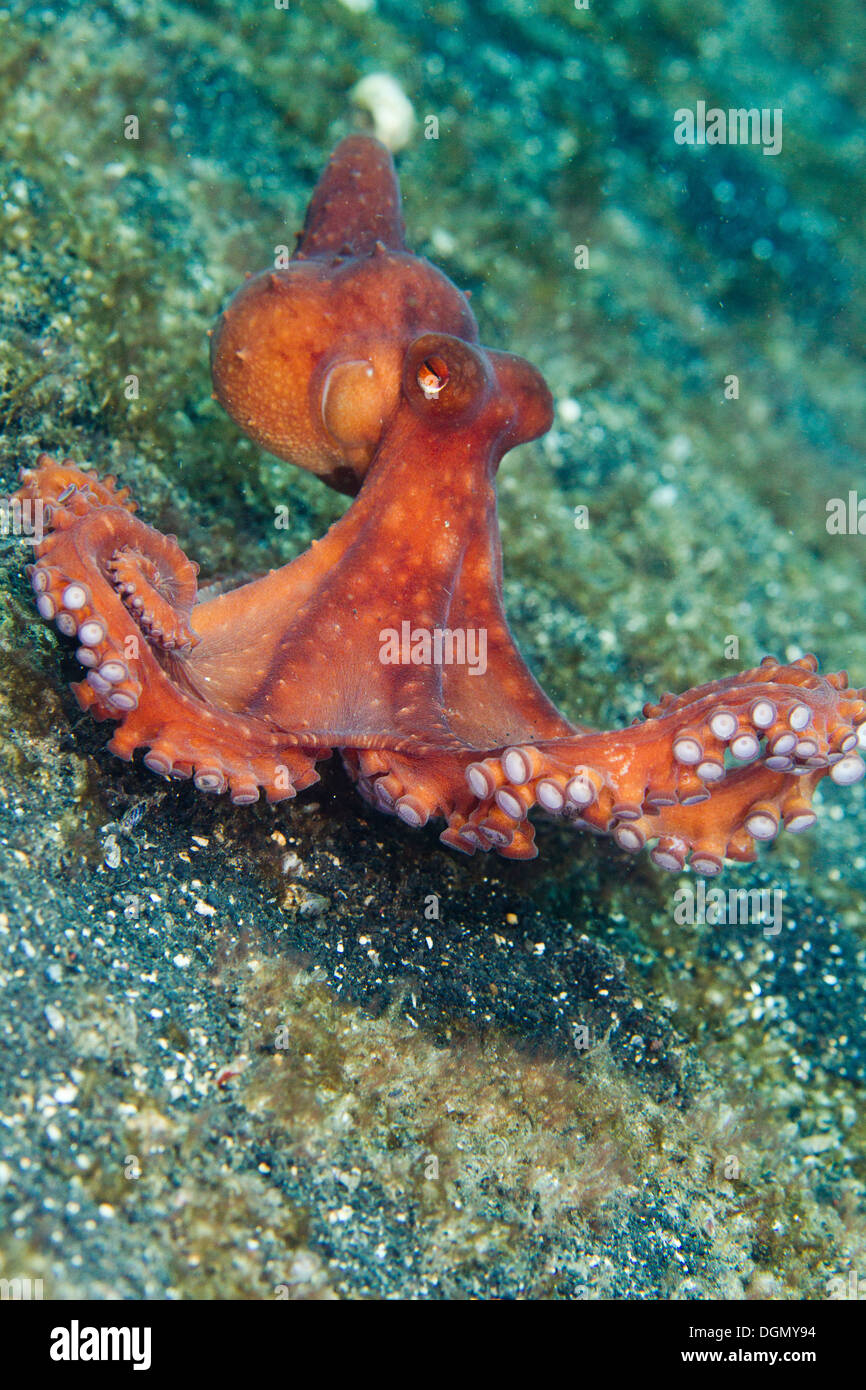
467,656,866,874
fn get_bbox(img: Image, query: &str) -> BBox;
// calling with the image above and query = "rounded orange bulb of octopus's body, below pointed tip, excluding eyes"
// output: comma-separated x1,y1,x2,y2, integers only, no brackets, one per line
211,249,478,496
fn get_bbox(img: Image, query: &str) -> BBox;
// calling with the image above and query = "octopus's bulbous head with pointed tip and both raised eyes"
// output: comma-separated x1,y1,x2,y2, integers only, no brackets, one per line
211,135,550,496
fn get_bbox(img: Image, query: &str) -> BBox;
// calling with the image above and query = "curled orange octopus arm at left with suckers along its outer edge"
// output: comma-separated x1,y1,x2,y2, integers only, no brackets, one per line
21,455,329,803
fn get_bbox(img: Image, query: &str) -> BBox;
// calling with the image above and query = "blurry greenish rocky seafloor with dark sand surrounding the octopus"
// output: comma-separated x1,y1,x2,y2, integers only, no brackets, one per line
0,0,866,1298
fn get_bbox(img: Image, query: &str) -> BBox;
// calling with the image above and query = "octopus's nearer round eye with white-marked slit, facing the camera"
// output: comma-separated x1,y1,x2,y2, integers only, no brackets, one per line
403,334,492,424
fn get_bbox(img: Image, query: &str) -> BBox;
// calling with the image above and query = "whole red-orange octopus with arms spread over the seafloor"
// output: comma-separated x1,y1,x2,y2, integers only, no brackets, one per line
17,135,866,876
